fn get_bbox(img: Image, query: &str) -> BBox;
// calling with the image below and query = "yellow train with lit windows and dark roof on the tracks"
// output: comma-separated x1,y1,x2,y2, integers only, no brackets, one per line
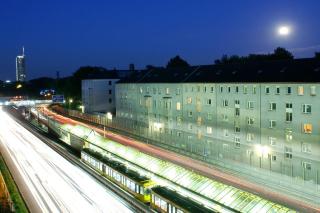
81,148,215,213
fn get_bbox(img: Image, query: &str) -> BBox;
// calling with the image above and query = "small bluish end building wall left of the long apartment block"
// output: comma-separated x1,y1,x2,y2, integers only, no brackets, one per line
81,78,119,114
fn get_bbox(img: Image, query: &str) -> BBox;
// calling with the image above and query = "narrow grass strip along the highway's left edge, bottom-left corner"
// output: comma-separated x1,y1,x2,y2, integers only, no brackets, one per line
0,155,29,213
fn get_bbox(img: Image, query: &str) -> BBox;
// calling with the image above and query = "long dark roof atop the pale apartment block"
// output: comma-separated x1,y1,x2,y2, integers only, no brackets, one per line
118,58,320,83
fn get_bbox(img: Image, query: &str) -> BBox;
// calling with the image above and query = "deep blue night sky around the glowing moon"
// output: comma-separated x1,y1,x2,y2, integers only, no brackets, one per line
0,0,320,80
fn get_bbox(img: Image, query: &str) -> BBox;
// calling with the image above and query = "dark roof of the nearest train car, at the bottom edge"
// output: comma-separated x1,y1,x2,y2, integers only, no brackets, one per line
152,186,214,213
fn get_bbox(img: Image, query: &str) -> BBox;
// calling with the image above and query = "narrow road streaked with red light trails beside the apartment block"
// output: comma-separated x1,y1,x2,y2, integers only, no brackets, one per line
42,107,320,212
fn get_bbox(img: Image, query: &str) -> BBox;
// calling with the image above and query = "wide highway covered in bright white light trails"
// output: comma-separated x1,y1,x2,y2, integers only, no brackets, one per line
0,109,132,212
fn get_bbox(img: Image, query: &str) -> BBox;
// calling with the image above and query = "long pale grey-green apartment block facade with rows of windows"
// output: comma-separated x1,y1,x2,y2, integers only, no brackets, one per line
116,59,320,202
